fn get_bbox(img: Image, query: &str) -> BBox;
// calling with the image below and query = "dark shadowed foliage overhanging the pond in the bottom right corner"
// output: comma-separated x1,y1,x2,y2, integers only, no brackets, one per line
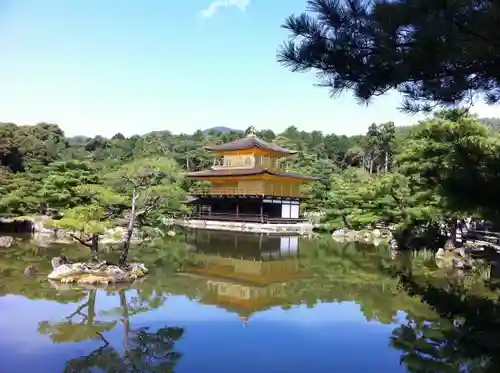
384,267,500,373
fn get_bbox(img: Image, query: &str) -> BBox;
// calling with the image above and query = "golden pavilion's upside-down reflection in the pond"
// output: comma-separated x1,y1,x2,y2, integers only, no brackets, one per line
187,230,306,324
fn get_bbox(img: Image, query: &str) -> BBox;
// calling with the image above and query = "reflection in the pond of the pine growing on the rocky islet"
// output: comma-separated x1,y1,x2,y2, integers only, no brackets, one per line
39,290,184,373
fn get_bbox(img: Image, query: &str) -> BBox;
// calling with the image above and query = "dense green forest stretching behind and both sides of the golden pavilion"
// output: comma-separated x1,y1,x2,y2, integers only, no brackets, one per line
0,110,500,246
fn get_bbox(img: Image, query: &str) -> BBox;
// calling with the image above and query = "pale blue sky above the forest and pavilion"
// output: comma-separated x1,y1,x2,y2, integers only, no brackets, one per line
0,0,500,136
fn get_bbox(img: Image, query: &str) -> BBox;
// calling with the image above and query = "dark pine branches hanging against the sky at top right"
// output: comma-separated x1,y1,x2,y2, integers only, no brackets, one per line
278,0,500,111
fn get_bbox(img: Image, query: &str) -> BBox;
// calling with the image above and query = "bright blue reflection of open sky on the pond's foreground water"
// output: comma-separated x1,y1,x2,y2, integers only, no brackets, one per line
0,292,404,373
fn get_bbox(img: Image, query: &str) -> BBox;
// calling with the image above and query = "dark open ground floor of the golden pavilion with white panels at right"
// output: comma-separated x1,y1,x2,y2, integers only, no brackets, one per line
185,197,304,223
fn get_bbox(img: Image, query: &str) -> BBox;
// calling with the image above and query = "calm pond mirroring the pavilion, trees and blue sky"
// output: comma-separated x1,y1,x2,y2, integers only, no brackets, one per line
0,231,494,373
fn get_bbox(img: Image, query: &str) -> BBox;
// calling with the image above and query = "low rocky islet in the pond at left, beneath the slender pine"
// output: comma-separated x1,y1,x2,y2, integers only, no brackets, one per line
48,262,148,285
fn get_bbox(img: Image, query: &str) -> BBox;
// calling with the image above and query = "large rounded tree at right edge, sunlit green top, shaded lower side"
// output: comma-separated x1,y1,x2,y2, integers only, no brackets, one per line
398,111,500,221
